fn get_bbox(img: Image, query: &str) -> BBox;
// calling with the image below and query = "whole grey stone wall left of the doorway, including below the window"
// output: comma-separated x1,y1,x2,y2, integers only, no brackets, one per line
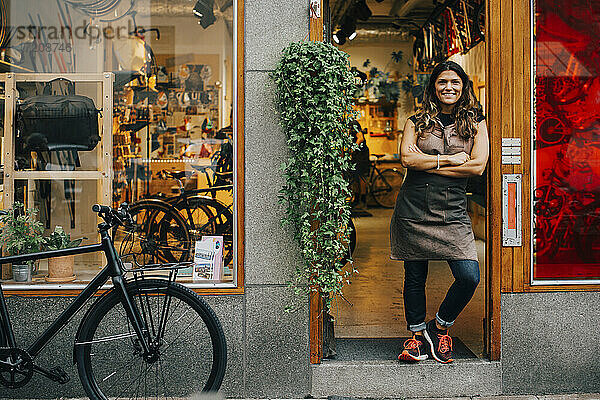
0,0,310,398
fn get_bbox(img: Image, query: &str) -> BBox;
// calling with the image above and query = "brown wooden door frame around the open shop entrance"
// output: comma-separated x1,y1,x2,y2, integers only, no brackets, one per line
309,0,532,364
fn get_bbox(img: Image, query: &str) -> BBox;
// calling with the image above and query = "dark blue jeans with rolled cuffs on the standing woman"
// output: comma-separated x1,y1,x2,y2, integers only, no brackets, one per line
404,260,479,332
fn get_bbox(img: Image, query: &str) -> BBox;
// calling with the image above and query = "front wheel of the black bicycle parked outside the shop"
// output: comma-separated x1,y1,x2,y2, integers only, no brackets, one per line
75,279,227,400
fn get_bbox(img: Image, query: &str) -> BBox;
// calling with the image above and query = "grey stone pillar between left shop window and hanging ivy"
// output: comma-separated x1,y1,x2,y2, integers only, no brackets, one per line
244,0,310,398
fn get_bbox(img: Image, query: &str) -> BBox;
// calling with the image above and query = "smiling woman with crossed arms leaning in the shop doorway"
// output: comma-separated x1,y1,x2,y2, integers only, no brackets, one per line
390,61,489,363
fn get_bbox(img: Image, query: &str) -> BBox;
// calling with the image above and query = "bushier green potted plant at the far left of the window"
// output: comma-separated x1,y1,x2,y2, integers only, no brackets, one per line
0,202,44,282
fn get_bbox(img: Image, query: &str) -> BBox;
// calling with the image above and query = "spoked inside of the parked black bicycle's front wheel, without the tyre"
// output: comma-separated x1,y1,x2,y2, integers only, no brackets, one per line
81,284,215,398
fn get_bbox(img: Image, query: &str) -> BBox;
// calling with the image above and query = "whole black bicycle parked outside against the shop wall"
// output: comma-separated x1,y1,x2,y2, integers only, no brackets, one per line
0,205,227,400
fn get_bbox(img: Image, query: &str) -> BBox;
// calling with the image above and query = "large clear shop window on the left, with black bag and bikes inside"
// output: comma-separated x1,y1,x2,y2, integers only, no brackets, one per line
0,0,239,288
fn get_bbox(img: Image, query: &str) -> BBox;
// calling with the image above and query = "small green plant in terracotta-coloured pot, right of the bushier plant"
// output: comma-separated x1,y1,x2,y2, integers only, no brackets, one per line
44,225,85,282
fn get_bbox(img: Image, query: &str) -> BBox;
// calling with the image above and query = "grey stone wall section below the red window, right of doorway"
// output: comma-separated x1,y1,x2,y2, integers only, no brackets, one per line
501,292,600,394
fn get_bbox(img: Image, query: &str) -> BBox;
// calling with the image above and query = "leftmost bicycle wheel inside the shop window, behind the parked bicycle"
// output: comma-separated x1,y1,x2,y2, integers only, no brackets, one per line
113,201,192,264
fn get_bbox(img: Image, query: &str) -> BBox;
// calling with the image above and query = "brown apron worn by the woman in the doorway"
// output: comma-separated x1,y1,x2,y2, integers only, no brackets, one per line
390,124,477,261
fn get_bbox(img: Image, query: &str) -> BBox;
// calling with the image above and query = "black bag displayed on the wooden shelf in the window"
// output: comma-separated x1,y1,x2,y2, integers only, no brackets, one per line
17,94,100,151
